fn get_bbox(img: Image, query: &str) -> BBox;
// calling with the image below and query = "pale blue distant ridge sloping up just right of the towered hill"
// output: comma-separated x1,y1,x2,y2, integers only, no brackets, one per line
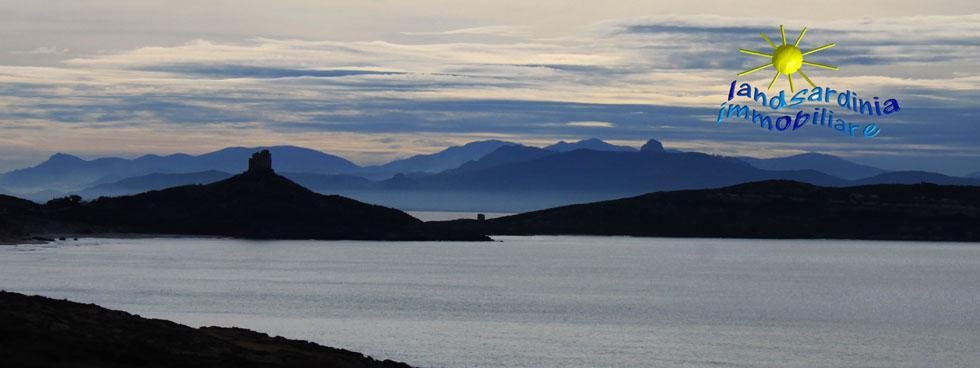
361,140,515,177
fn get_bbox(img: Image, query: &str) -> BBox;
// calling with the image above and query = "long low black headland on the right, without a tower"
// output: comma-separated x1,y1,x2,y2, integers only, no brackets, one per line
434,181,980,241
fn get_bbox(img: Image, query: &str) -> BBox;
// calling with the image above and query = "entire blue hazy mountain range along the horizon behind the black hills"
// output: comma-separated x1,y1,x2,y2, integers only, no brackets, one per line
0,139,980,212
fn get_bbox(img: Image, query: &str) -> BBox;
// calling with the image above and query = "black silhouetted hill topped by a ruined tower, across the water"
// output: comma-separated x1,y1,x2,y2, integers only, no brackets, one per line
1,151,488,240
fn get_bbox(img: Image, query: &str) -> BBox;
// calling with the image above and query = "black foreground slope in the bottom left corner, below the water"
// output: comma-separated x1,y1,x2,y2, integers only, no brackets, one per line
0,291,409,368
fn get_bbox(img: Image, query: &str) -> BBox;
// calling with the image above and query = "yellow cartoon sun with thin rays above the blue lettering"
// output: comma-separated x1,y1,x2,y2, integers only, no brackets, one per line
738,25,840,92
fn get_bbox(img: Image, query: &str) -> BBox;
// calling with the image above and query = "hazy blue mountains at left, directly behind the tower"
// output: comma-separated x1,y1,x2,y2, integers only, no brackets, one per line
0,146,359,193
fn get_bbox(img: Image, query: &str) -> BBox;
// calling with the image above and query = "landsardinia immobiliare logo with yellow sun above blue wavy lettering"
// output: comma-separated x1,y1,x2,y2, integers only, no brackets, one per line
717,25,901,138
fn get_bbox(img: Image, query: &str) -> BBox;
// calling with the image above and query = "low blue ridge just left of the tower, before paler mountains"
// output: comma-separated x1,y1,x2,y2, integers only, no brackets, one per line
78,170,231,198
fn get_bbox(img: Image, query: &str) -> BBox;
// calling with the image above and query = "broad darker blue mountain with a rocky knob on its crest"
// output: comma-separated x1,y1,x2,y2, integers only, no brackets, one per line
341,146,848,212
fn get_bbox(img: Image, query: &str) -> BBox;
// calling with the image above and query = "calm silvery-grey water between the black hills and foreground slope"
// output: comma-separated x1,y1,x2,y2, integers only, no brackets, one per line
0,237,980,368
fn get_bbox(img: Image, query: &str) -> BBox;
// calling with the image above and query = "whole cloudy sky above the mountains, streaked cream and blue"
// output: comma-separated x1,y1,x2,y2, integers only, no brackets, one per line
0,0,980,175
